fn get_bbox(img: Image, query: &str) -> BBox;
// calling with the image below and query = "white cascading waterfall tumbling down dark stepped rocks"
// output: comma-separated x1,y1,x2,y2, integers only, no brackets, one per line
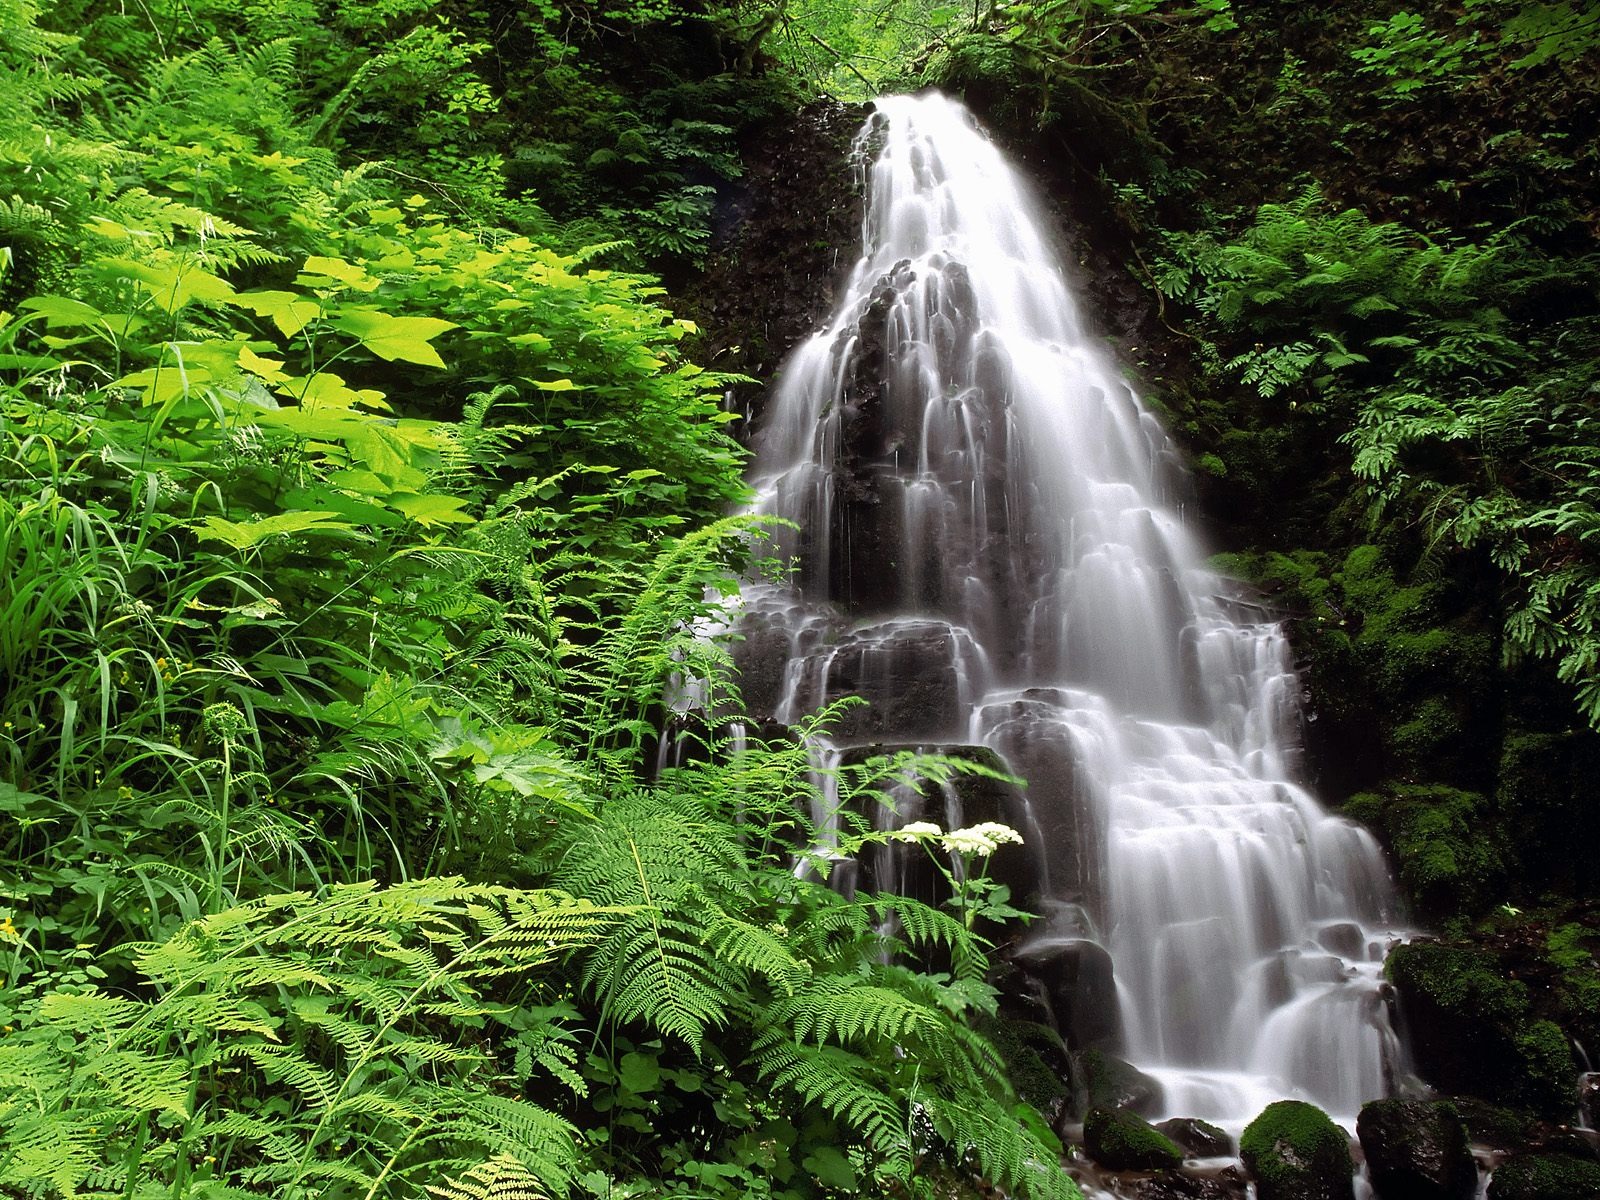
742,94,1395,1128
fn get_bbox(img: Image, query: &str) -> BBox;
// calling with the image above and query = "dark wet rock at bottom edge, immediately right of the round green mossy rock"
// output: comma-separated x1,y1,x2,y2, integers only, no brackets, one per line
1355,1099,1478,1200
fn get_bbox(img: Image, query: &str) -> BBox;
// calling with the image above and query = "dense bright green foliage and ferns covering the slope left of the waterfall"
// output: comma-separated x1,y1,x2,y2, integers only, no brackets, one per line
0,0,1075,1200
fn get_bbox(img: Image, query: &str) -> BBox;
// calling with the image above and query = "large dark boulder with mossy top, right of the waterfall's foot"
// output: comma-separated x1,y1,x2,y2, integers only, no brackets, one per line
1384,942,1578,1120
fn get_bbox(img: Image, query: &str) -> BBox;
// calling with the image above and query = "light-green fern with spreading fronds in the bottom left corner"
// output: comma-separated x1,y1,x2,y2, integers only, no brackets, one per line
0,880,627,1195
